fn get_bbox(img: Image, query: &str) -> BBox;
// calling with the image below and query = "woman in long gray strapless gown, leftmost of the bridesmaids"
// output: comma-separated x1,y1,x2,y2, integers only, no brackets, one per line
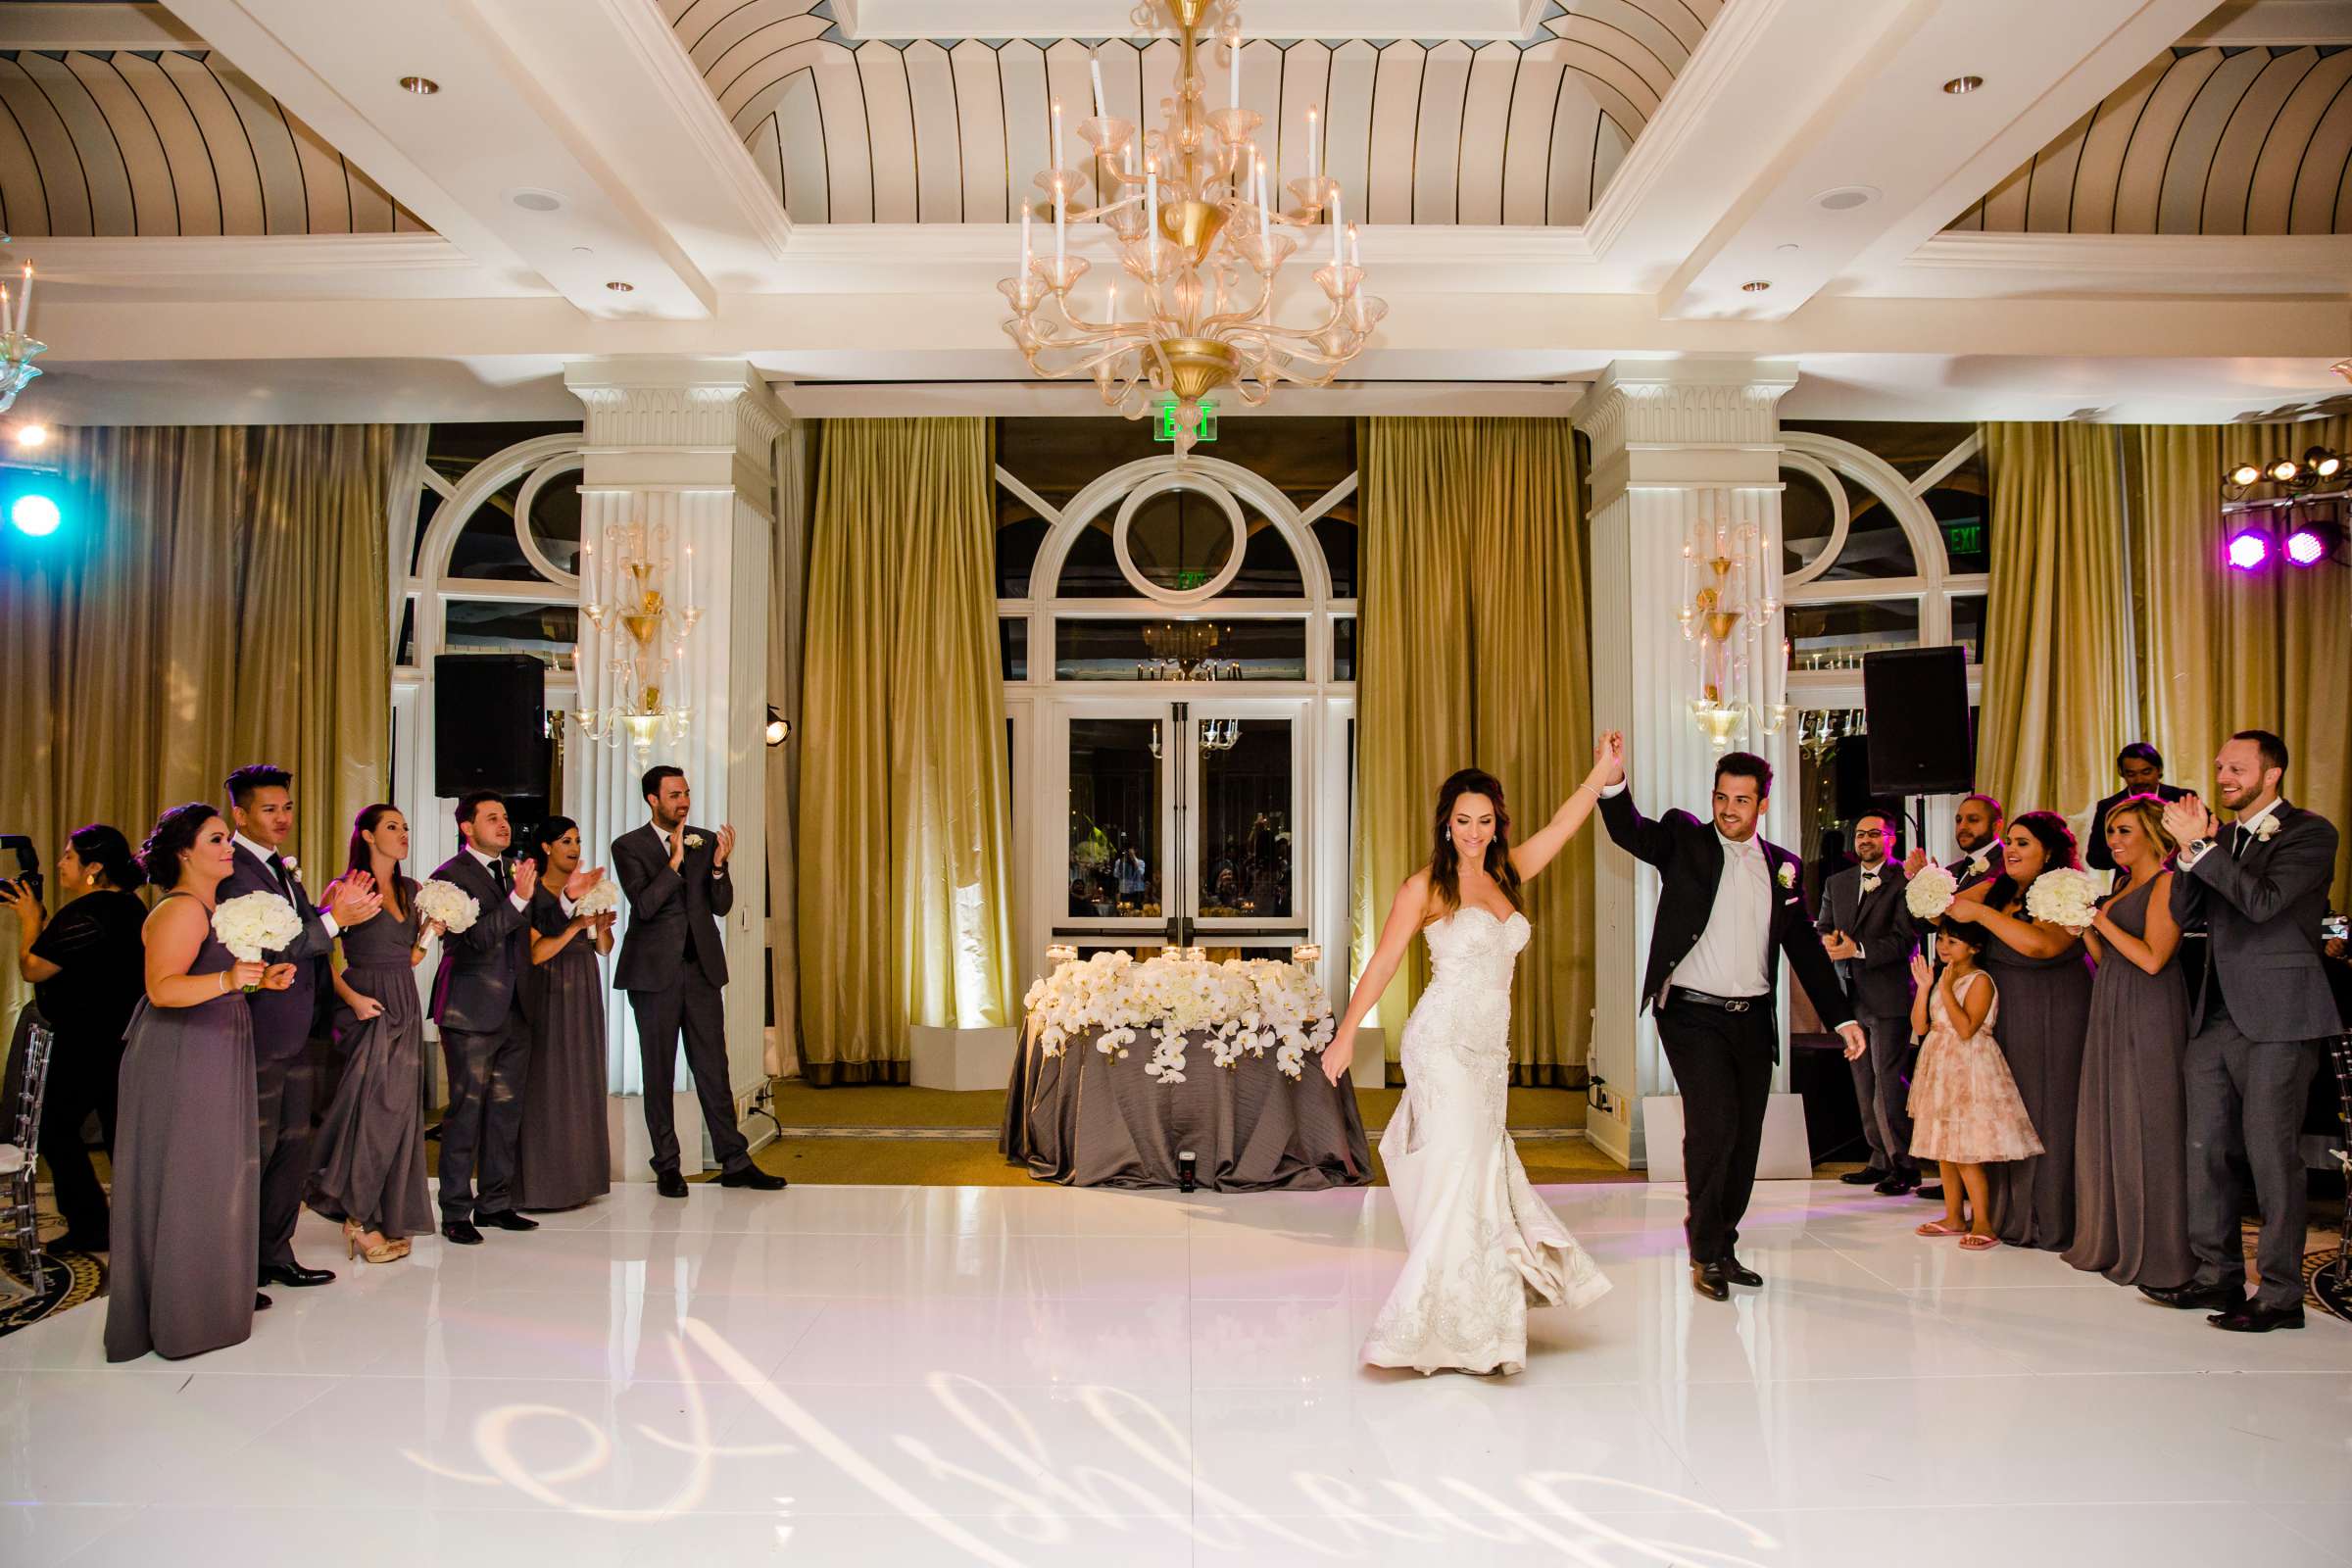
106,802,294,1361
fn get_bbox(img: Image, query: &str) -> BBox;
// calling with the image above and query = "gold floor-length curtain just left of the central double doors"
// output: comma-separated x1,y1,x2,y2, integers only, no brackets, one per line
795,418,1021,1086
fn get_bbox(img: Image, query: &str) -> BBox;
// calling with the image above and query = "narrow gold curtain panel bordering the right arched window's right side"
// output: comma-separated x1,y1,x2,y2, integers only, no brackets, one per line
1976,423,2131,815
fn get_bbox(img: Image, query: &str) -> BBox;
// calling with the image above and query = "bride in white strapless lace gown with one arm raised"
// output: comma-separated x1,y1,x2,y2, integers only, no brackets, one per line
1322,741,1609,1373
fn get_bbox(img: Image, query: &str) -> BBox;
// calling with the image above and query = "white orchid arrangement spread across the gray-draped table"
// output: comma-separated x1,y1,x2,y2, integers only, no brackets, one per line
1023,953,1339,1084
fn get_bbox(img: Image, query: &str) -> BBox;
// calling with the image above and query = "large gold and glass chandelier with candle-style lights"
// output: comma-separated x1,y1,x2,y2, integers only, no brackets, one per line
998,0,1388,454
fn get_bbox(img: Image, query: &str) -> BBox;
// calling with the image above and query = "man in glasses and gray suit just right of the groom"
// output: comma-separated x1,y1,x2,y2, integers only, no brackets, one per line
1813,811,1919,1197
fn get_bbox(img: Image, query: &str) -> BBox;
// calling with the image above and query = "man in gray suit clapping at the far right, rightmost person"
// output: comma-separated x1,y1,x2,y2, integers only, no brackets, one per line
2142,729,2342,1333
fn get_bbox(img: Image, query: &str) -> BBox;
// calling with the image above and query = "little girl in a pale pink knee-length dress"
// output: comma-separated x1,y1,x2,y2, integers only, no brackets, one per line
1910,919,2041,1253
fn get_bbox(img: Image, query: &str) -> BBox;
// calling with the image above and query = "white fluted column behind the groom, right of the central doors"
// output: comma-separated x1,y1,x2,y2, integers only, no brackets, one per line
1576,360,1797,1166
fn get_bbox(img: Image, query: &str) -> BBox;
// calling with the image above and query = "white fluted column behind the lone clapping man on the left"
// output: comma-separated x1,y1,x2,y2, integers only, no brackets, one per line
564,358,788,1180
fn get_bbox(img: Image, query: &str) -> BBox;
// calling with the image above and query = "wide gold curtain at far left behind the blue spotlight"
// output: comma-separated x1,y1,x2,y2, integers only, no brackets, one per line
0,425,423,1024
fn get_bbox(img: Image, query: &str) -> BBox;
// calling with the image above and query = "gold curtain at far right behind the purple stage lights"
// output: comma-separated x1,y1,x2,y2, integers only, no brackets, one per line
2135,418,2352,909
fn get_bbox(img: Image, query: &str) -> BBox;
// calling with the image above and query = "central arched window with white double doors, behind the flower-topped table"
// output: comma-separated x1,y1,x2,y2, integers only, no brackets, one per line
998,418,1357,987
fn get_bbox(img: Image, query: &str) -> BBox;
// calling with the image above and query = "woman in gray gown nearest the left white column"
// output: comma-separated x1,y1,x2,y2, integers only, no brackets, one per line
515,815,618,1208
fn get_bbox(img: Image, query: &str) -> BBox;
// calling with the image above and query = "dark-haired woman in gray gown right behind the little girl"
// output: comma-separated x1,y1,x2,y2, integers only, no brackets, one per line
1950,811,2091,1253
